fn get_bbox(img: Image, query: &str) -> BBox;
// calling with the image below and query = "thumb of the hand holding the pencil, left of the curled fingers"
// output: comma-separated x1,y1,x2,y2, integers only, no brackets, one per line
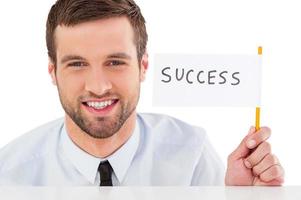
229,126,256,160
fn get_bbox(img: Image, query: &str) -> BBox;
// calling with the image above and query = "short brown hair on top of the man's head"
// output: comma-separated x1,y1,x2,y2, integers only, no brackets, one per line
46,0,147,65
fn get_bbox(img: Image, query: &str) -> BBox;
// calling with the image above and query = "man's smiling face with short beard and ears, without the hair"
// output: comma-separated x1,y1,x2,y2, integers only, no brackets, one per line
49,17,148,138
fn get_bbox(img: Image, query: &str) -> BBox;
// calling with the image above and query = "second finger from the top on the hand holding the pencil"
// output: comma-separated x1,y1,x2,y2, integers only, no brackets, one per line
244,142,271,168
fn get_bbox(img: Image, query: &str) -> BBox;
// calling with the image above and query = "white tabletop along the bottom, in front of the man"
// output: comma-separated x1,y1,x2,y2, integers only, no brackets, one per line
0,186,301,200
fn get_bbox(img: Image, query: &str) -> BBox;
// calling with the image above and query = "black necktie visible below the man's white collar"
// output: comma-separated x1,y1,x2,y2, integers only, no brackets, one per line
98,160,113,186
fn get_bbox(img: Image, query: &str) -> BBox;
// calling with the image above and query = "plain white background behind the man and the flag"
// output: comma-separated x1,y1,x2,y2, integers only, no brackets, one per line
0,0,301,185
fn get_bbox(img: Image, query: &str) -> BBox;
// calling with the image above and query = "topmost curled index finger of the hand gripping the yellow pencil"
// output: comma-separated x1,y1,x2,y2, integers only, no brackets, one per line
246,127,271,149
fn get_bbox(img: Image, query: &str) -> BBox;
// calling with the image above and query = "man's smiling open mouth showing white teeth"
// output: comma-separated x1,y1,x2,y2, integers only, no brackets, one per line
82,99,119,114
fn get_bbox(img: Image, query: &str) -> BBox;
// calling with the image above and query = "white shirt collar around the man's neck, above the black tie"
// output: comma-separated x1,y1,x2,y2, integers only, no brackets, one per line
61,119,140,184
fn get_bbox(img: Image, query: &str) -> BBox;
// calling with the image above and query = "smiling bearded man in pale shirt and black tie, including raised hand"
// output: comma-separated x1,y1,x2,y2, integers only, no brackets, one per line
0,0,283,186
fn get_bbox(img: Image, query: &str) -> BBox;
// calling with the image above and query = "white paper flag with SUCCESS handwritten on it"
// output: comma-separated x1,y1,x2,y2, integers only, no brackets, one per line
153,54,261,107
